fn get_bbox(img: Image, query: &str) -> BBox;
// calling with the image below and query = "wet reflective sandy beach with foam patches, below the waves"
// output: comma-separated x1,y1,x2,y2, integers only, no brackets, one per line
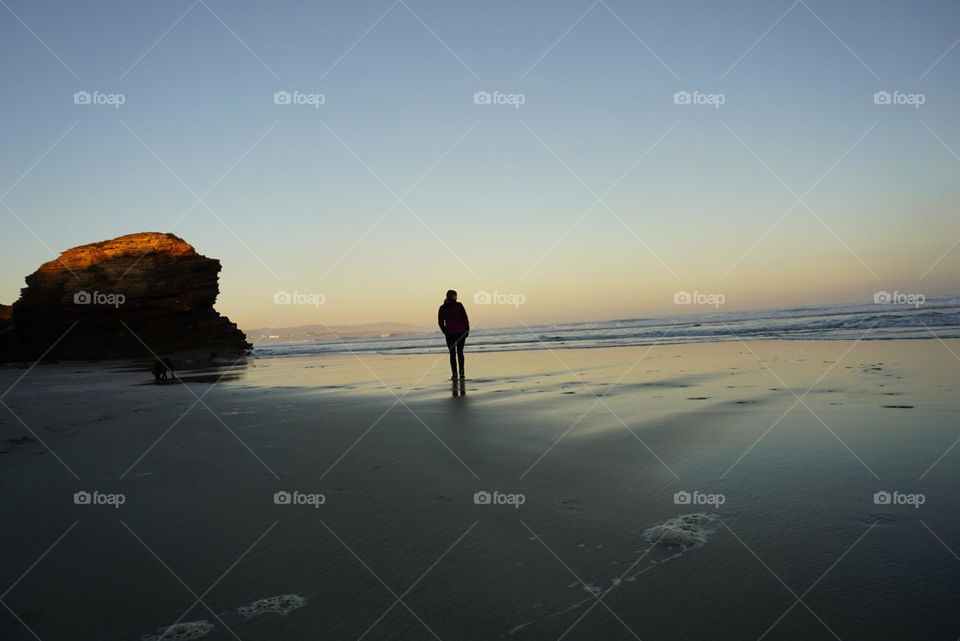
0,339,960,641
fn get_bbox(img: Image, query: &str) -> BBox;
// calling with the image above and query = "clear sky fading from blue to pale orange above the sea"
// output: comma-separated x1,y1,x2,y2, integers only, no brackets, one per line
0,0,960,328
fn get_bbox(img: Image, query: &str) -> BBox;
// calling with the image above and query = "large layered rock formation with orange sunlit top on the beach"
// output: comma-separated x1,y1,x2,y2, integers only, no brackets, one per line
0,232,251,361
